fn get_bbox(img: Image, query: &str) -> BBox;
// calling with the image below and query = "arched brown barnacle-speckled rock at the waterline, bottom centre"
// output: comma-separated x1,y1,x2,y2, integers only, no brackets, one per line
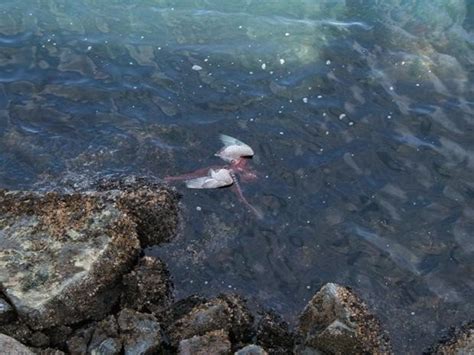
169,295,253,345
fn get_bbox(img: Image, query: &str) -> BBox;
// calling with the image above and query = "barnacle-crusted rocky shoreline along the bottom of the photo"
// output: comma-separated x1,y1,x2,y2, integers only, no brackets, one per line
0,179,474,355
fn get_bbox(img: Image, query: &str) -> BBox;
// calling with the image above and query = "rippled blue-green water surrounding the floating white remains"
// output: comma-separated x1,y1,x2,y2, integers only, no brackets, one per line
0,0,474,353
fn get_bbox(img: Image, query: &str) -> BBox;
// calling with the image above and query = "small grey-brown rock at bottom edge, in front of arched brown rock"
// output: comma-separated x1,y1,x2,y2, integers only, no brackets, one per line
178,330,231,355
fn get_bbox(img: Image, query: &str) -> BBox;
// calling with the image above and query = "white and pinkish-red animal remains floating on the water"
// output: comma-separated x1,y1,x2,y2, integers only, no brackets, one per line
165,134,263,219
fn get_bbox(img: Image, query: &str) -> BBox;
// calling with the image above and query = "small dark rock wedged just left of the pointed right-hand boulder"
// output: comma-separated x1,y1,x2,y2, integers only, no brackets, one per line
256,312,294,354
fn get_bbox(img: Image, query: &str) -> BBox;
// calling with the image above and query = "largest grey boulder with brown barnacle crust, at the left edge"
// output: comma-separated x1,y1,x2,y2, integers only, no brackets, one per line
0,183,177,329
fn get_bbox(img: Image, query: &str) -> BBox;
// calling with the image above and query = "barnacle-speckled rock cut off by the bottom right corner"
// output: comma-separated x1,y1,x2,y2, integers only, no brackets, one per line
425,321,474,355
